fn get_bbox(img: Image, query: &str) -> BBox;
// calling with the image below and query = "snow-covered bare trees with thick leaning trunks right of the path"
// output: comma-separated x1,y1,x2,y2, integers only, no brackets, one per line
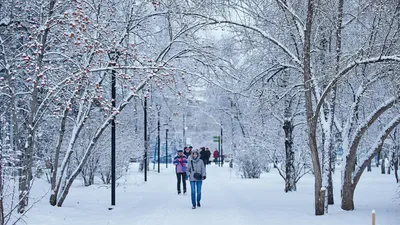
191,0,400,215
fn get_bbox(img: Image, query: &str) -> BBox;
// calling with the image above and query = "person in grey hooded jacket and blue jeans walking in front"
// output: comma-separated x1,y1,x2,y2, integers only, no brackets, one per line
186,150,206,209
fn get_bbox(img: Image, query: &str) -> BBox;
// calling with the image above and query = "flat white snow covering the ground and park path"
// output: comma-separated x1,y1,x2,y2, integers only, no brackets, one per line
25,165,400,225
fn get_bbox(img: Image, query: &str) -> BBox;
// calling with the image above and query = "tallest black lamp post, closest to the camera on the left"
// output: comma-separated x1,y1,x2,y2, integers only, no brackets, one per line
111,65,117,205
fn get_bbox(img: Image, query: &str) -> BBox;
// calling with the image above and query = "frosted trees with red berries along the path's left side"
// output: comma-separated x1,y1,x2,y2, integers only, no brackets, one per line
0,0,225,224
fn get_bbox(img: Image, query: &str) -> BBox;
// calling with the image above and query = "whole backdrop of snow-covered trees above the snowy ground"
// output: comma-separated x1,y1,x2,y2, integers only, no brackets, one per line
0,0,400,224
